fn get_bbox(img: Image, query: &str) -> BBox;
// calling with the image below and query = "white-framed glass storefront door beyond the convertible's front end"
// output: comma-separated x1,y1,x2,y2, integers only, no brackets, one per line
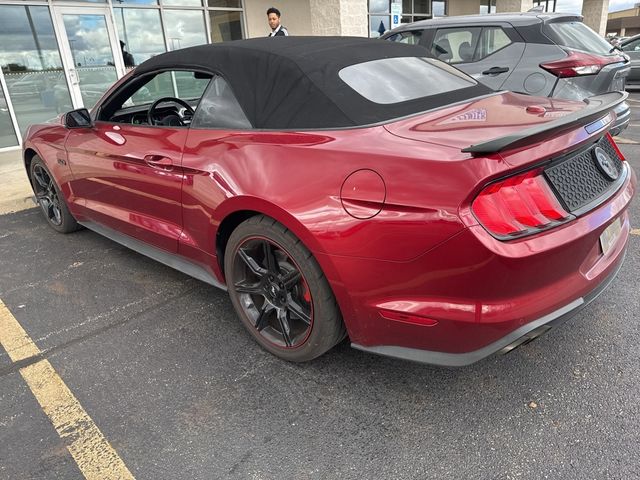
54,7,124,108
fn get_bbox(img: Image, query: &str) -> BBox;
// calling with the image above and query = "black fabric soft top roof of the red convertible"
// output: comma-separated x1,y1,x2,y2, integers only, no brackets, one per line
134,36,489,129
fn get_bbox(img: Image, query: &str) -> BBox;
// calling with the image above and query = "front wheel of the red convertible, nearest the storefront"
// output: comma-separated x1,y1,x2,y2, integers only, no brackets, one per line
29,155,80,233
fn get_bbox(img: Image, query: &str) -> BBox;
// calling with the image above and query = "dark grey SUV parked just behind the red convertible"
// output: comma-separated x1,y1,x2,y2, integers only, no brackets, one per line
381,12,631,135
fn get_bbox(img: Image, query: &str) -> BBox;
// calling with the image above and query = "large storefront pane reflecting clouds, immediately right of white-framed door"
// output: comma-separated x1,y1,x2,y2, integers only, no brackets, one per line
113,8,165,70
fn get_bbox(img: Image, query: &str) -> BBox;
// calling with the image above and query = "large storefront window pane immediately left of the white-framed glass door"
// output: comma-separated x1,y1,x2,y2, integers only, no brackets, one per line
0,5,73,135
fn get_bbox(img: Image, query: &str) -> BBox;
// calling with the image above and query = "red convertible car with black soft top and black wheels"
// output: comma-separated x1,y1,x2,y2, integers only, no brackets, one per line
24,37,636,366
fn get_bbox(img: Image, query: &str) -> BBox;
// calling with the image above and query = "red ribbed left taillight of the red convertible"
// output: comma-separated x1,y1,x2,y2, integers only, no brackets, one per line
472,169,571,238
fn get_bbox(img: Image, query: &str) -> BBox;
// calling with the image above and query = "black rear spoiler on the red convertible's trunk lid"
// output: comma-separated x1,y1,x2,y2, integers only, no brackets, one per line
462,92,629,155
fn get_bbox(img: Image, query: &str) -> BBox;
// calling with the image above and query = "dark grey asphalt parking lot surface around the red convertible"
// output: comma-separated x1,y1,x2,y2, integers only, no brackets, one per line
0,93,640,479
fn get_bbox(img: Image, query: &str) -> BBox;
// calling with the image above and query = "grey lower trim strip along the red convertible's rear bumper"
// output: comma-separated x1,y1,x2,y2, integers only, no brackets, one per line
351,250,626,367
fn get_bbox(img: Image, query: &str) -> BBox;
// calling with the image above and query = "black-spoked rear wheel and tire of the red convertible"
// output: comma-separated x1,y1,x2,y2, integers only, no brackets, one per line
224,215,346,362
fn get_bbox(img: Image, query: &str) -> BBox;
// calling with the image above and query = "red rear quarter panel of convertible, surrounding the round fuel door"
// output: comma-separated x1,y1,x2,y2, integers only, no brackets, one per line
178,127,483,261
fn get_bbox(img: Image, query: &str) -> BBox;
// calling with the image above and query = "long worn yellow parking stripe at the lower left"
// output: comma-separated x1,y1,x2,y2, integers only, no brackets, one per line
0,300,134,480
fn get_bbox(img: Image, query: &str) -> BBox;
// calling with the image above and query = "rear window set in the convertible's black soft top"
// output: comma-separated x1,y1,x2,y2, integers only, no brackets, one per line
339,57,477,105
